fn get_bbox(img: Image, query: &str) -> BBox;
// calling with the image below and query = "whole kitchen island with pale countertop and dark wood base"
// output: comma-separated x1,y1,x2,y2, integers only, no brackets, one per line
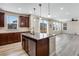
22,33,55,56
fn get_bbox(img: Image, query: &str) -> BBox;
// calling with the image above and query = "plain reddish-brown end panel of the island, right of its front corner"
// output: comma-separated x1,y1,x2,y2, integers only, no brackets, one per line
36,38,49,56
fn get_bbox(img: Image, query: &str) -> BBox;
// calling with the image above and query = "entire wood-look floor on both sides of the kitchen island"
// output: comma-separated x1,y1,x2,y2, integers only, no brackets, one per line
0,34,79,56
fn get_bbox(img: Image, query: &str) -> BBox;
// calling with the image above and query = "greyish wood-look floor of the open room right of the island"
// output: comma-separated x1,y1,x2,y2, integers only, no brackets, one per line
56,34,79,56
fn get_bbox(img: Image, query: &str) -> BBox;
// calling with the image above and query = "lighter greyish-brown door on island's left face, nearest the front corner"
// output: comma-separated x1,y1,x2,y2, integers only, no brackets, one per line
28,39,36,56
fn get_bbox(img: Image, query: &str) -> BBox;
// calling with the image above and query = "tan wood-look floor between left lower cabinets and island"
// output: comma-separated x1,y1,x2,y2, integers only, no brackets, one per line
0,42,28,56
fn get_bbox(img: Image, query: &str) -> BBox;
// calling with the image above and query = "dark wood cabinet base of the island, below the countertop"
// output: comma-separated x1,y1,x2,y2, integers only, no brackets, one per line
22,35,49,56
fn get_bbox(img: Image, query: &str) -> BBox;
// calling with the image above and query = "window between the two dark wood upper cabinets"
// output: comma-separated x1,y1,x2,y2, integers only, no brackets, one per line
7,16,17,29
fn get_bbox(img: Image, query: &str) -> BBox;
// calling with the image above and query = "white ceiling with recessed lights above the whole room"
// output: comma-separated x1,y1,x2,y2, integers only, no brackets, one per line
0,3,79,21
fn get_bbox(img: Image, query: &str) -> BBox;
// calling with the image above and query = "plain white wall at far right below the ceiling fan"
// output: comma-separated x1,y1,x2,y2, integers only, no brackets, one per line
64,21,79,34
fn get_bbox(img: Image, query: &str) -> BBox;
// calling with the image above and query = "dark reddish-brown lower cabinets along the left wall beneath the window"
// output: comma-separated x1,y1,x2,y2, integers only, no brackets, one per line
0,33,21,45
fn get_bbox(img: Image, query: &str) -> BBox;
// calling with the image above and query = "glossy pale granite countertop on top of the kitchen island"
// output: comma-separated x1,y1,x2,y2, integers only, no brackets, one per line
22,33,55,40
